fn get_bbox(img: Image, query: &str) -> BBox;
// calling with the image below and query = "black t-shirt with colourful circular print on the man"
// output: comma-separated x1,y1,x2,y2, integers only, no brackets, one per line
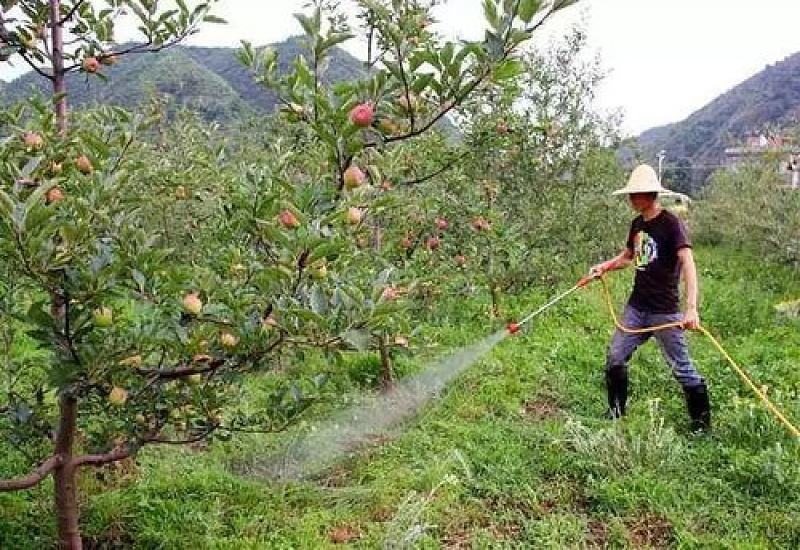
626,210,692,313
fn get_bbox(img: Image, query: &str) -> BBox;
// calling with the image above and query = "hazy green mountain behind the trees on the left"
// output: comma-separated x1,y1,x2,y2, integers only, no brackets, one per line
0,38,362,123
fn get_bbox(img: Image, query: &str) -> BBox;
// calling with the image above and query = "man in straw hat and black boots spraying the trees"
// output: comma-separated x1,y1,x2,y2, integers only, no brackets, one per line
591,164,711,432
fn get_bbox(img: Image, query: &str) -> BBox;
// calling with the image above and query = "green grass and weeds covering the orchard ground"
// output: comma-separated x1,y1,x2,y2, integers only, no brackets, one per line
0,248,800,549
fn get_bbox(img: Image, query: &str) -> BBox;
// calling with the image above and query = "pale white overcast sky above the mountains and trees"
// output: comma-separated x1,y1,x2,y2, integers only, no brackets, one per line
0,0,800,135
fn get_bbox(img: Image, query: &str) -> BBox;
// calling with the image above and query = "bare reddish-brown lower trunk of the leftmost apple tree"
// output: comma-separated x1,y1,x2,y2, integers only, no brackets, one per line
53,391,83,550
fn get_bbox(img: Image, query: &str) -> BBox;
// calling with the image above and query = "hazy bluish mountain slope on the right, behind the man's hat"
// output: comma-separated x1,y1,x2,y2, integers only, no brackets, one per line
638,53,800,188
